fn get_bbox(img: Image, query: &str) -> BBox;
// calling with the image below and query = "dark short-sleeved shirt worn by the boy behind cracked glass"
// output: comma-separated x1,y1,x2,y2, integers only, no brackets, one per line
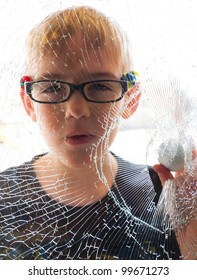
0,154,180,260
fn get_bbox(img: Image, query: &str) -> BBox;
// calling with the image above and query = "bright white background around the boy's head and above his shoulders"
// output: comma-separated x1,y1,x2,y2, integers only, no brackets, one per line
0,0,197,170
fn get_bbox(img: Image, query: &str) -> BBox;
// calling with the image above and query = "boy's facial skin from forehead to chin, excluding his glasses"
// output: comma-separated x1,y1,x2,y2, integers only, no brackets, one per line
23,37,137,168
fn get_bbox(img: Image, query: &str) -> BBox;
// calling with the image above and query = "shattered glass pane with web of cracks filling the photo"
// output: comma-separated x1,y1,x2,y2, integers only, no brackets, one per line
0,0,197,260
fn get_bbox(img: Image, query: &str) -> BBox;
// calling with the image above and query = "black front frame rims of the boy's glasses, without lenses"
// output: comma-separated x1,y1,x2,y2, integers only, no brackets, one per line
23,80,129,104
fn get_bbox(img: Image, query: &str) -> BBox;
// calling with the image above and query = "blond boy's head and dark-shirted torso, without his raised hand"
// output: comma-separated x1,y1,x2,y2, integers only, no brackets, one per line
0,7,195,259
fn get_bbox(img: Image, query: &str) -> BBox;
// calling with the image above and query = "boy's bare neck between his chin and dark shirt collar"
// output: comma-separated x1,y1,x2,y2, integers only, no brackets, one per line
33,153,118,206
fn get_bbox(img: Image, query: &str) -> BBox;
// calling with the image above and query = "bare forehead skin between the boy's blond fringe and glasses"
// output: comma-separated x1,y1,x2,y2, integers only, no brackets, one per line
31,38,123,82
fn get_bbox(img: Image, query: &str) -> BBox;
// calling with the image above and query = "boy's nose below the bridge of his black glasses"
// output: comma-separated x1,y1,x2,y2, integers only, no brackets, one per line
64,90,91,119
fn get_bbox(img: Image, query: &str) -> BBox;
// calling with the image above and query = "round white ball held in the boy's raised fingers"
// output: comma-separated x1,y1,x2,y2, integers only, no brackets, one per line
158,139,186,171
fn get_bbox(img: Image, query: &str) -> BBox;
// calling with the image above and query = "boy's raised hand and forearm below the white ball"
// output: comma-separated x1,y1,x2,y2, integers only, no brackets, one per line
153,150,197,259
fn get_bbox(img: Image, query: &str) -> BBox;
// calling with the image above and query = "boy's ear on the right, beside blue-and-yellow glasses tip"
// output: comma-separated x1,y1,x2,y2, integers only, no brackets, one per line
122,83,141,119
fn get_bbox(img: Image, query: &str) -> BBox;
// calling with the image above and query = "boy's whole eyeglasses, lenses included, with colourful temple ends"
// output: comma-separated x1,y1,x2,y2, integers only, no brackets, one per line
21,72,137,104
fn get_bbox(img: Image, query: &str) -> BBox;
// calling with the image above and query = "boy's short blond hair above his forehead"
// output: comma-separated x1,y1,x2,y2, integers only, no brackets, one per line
25,6,132,75
